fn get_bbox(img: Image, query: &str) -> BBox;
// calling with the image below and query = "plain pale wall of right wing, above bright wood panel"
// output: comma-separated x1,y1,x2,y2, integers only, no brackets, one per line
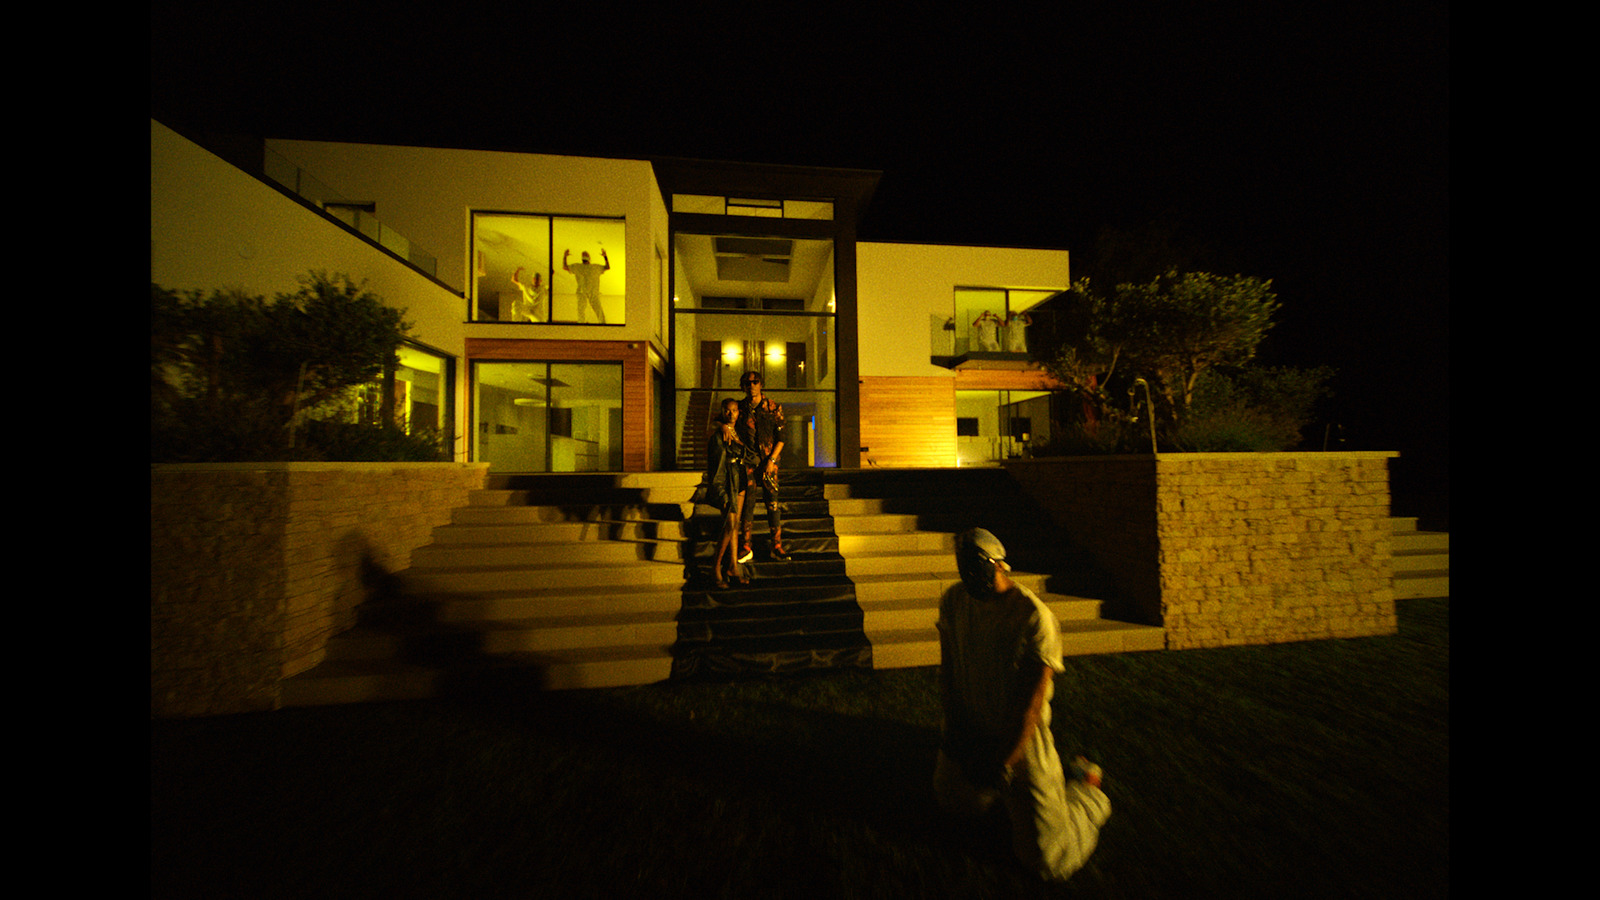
856,243,1072,378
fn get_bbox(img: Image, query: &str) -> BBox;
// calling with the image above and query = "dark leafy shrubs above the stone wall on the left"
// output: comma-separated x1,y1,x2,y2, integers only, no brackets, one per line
150,272,435,461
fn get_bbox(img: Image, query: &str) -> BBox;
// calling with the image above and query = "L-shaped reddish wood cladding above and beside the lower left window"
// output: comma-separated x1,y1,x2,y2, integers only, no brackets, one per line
467,338,656,472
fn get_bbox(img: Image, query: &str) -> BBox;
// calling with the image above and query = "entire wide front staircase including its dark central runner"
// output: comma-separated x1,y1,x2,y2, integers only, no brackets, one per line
283,469,1165,706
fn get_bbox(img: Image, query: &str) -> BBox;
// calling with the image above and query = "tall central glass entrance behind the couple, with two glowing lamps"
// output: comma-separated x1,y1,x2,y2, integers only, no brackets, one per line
672,234,838,468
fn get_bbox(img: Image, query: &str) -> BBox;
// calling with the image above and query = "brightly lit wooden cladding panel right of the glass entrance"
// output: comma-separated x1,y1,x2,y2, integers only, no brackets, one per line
861,376,955,468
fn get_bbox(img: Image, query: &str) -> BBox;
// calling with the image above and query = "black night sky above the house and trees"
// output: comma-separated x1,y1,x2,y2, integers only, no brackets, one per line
150,0,1450,506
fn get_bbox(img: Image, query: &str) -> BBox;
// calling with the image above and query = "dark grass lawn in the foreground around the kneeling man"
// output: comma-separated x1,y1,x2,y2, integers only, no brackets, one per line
150,599,1450,898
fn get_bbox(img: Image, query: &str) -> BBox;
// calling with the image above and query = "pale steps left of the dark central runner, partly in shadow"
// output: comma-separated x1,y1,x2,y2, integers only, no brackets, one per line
283,472,699,706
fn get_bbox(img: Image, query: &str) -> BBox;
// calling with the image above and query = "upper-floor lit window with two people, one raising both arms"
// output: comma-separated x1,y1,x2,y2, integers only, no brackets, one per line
472,213,627,325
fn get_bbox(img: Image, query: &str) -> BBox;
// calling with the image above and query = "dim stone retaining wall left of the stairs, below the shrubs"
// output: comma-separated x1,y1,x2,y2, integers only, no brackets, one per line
150,463,488,716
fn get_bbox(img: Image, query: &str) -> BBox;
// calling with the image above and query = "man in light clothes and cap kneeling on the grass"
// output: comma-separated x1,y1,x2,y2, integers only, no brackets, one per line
933,528,1110,881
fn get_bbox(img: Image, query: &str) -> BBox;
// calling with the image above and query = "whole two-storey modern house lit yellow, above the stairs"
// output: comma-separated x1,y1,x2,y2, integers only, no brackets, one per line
150,120,1070,472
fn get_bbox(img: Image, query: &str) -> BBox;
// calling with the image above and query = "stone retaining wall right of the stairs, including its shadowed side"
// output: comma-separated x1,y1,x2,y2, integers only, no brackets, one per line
1006,452,1398,649
